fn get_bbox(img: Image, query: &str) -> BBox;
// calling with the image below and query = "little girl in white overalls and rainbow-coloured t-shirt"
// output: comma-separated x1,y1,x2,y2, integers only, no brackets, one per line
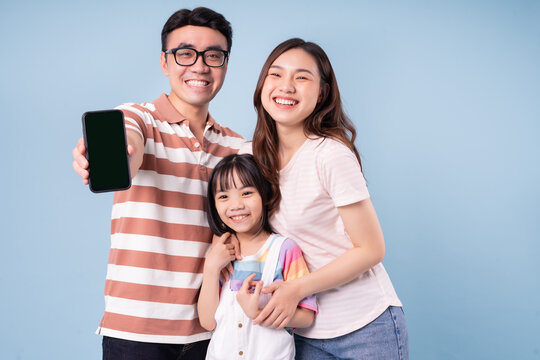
198,154,317,360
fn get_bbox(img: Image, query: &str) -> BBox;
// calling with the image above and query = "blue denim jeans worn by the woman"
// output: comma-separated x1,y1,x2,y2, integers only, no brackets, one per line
294,306,409,360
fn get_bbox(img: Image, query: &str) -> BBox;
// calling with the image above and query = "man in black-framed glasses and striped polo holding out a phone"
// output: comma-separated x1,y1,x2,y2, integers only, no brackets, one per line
73,7,244,360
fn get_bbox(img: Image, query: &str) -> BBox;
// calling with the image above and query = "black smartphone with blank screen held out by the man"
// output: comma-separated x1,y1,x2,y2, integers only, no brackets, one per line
82,110,131,193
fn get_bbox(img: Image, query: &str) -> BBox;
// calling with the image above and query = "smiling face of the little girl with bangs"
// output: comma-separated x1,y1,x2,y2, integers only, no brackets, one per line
214,173,263,235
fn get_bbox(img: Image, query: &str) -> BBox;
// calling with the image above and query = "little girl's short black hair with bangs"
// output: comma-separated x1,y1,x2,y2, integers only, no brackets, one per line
206,154,274,236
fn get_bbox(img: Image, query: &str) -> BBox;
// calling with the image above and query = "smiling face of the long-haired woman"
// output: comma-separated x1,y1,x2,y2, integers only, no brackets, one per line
261,49,321,129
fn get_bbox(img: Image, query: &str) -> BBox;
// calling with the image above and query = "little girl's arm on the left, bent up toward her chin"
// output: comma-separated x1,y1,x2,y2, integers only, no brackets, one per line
197,233,235,331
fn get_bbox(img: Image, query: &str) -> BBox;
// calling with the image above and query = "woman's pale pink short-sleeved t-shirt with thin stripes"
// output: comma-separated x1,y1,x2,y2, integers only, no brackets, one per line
271,138,401,339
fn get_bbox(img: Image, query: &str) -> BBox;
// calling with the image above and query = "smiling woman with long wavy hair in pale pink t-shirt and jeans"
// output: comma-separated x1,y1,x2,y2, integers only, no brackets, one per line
253,39,408,360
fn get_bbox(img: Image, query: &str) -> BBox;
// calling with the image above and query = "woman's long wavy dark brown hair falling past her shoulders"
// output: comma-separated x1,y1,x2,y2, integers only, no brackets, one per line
253,38,362,213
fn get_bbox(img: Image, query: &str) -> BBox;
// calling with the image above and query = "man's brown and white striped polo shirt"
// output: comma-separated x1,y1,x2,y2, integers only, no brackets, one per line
97,94,244,344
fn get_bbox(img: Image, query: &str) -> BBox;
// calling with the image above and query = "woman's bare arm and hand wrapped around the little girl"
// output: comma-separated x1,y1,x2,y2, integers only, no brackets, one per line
253,199,385,328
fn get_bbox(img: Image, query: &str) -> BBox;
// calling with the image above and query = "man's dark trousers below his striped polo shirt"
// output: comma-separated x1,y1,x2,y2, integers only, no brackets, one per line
103,336,210,360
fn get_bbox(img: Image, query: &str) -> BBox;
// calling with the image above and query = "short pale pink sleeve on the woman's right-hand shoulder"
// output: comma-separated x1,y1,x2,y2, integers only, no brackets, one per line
317,139,369,207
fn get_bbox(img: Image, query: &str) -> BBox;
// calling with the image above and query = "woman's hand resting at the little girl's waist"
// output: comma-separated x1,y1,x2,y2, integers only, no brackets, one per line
253,281,302,329
